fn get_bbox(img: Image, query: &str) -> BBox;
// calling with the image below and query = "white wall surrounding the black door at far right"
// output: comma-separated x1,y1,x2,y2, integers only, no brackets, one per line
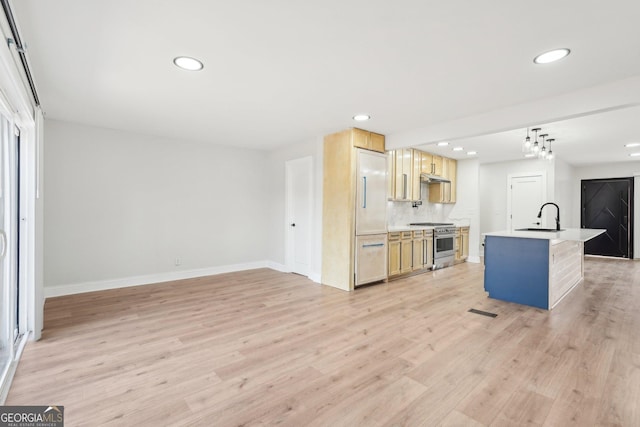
572,161,640,258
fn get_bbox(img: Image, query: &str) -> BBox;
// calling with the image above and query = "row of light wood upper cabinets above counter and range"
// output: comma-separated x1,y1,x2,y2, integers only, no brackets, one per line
387,148,457,203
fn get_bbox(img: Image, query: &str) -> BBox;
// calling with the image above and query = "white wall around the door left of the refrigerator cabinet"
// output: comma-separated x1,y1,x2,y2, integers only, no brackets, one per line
267,137,323,282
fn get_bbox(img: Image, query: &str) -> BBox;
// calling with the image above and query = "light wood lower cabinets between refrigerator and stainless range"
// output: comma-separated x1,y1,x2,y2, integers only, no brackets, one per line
388,230,433,277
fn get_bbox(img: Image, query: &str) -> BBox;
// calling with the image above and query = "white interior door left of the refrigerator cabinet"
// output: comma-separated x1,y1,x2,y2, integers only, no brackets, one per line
285,157,313,276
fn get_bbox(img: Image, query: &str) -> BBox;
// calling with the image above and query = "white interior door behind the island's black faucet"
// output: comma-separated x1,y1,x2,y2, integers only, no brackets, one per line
507,173,547,230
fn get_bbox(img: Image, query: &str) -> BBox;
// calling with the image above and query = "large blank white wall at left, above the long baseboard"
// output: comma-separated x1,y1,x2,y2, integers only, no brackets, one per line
44,120,270,295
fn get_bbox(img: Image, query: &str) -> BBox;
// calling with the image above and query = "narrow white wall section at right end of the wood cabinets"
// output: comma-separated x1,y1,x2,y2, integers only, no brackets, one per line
448,159,481,262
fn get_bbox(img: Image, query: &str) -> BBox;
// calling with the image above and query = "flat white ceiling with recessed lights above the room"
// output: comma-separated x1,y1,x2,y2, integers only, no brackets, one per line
12,0,640,164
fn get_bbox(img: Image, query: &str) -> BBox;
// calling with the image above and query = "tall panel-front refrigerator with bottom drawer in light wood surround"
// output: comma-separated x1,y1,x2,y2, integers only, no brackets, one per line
355,149,388,286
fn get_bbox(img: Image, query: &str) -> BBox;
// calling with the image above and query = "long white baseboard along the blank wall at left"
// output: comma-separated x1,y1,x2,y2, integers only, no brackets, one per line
44,261,278,299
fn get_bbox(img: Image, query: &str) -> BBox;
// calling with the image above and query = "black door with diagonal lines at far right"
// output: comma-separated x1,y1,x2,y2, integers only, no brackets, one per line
580,178,633,258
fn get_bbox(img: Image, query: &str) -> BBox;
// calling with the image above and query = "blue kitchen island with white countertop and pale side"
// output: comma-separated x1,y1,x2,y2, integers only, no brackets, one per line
484,228,605,310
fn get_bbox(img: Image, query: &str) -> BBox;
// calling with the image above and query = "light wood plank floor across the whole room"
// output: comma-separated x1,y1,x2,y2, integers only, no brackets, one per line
6,259,640,426
